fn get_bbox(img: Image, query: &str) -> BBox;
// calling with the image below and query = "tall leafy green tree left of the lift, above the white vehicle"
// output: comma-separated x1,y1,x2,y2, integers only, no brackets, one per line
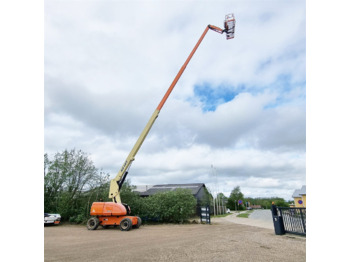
44,149,108,220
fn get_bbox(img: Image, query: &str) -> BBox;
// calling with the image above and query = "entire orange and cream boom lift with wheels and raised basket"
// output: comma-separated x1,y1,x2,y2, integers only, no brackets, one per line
87,14,236,231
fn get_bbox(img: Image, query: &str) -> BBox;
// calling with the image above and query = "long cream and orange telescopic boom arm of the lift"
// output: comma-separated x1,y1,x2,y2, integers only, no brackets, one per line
109,16,235,203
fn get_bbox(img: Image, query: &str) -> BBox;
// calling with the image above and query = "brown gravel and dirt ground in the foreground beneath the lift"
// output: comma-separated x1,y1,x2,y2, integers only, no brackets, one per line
44,216,306,262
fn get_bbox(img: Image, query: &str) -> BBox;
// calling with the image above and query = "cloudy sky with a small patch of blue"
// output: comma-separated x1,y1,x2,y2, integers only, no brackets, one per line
44,0,306,199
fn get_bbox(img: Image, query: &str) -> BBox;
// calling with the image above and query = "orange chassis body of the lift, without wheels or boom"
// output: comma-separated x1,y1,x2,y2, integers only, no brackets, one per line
90,202,137,226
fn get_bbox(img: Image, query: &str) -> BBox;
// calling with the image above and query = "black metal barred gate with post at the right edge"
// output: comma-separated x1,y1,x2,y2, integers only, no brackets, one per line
271,205,306,236
